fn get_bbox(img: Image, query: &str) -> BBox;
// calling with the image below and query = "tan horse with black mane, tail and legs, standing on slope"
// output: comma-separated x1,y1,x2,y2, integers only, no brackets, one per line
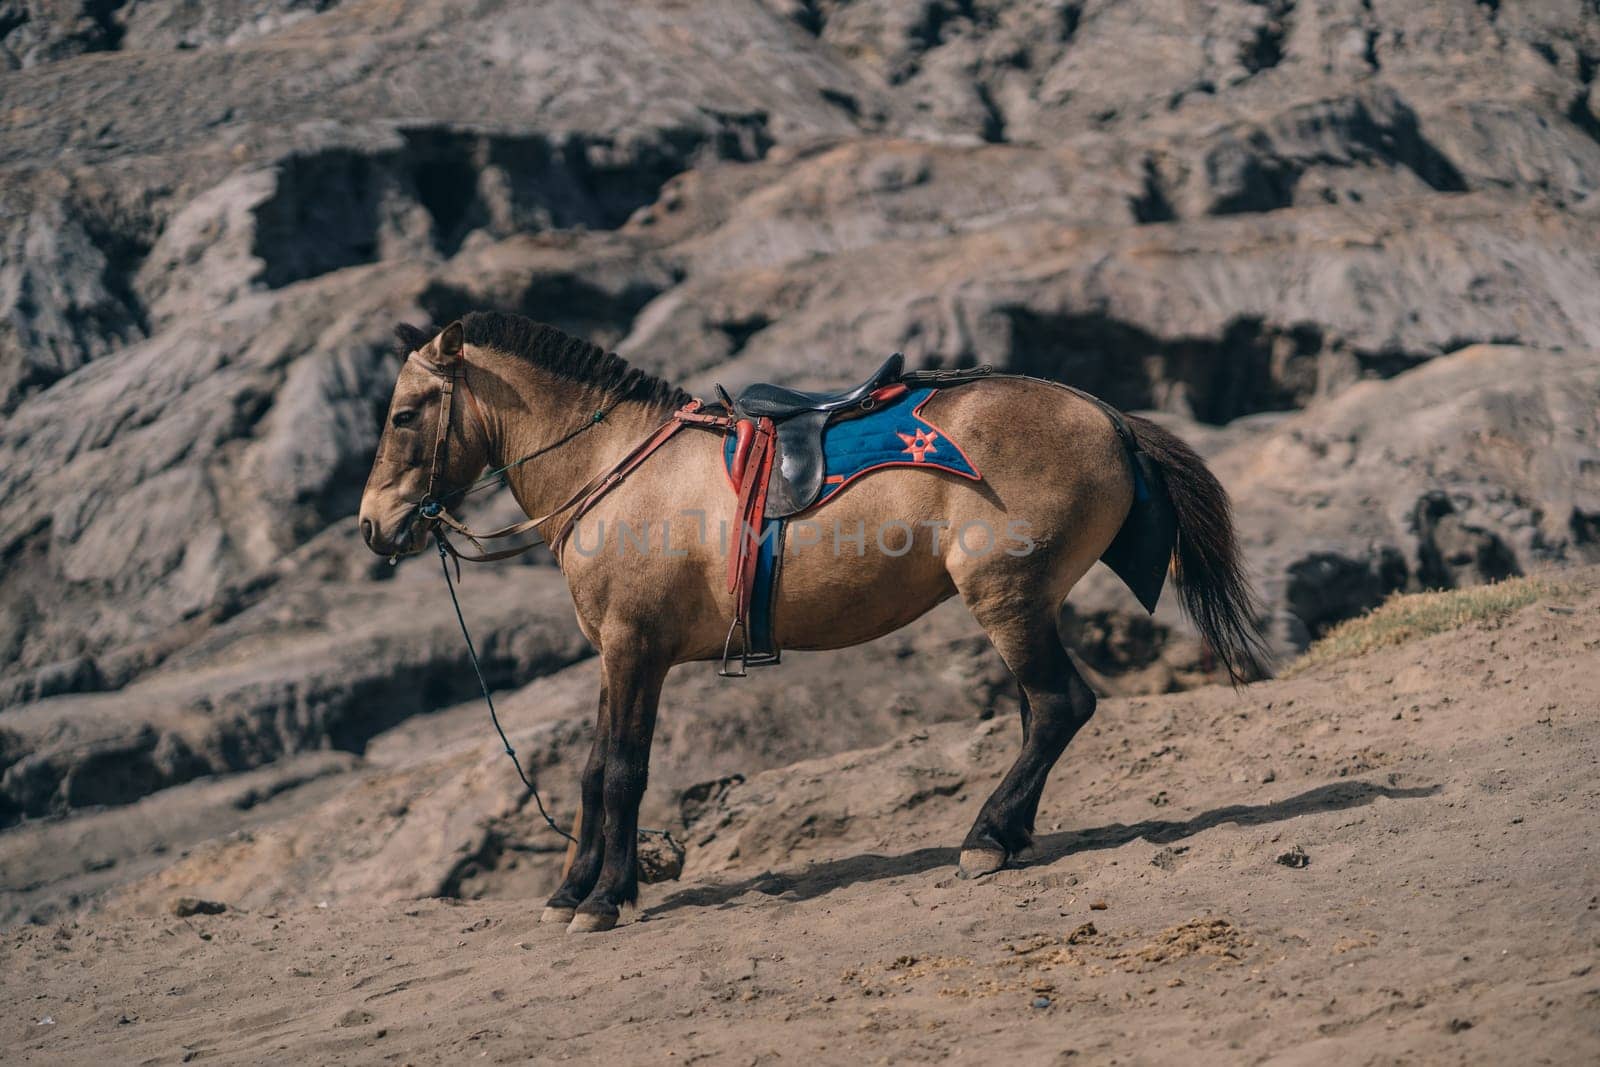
358,312,1264,933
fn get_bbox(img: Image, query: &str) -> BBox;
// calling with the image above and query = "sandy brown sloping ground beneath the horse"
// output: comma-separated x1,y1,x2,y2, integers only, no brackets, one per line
0,569,1600,1064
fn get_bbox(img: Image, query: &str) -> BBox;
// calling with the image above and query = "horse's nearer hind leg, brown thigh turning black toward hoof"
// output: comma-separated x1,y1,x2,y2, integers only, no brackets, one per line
958,568,1094,878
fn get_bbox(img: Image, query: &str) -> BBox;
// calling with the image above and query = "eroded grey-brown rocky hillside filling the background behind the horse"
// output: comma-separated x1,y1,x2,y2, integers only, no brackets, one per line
0,0,1600,813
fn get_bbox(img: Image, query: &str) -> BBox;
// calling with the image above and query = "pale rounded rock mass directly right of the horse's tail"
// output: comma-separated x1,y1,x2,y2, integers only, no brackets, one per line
1216,346,1600,653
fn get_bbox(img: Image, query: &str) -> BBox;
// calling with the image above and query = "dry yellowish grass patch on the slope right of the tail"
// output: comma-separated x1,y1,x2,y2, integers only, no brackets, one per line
1278,577,1562,678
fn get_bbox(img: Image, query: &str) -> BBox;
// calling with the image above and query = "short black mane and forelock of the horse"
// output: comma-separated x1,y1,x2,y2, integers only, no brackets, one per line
395,312,690,406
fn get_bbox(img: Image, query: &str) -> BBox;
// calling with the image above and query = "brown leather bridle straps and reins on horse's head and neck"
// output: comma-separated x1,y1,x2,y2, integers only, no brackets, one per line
403,351,736,566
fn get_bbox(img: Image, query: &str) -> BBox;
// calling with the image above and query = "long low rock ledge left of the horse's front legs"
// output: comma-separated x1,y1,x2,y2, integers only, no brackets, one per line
0,568,592,822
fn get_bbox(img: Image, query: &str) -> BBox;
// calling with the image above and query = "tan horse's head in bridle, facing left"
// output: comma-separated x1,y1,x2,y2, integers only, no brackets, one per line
360,322,488,555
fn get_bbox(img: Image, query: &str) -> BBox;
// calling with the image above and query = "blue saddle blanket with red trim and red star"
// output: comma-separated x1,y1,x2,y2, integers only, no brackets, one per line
723,389,982,665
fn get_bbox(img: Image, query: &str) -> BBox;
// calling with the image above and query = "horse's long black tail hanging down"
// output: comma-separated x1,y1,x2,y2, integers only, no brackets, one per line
1123,414,1270,685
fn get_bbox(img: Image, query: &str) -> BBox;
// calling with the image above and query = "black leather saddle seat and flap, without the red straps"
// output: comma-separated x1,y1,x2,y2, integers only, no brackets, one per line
731,352,906,518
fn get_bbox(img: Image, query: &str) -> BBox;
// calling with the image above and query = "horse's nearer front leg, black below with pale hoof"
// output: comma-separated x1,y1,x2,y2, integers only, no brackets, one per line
568,637,670,933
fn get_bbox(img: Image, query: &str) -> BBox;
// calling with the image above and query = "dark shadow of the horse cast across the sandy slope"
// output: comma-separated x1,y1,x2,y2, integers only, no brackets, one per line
642,782,1440,918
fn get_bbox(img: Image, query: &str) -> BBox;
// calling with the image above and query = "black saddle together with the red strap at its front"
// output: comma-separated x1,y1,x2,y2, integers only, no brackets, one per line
718,352,906,518
